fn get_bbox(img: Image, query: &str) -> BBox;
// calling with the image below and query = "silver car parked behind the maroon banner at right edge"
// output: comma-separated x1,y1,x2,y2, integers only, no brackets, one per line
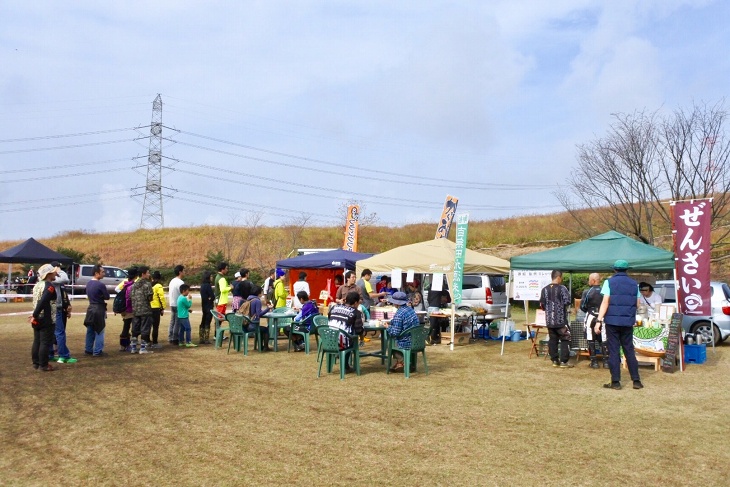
654,281,730,345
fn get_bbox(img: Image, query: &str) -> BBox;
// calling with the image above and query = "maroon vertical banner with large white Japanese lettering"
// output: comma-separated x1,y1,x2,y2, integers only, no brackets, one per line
672,199,712,316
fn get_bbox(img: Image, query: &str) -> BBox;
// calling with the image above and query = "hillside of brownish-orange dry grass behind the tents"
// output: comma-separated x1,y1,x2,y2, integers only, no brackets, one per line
0,213,730,280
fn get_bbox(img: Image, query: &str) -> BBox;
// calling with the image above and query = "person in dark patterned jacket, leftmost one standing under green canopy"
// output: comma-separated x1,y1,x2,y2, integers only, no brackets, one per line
540,270,573,369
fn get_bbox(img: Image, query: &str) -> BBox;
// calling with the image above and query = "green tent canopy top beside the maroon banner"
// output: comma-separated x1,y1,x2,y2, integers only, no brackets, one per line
510,230,674,272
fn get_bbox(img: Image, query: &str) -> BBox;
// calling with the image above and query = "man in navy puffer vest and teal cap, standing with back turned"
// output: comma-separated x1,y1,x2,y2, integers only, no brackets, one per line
596,259,644,390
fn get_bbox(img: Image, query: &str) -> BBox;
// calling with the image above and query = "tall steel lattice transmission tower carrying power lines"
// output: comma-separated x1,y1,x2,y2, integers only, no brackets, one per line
139,93,165,228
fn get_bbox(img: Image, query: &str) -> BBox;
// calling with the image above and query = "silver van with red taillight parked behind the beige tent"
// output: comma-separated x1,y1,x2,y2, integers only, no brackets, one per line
423,274,512,323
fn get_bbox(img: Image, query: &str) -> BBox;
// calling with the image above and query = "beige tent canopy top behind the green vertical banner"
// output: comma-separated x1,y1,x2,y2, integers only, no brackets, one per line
356,238,509,286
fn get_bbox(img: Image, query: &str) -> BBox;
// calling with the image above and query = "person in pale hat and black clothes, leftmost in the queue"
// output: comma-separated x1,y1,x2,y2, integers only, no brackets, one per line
28,264,57,372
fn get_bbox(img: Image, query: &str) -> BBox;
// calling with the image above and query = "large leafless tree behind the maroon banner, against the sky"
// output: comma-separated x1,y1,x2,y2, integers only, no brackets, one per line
554,100,730,254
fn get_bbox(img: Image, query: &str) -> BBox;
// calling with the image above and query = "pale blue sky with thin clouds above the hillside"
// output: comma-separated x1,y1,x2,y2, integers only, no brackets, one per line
0,0,730,241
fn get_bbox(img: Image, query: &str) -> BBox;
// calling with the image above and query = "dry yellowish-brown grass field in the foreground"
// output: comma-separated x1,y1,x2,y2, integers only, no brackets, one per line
0,302,730,486
